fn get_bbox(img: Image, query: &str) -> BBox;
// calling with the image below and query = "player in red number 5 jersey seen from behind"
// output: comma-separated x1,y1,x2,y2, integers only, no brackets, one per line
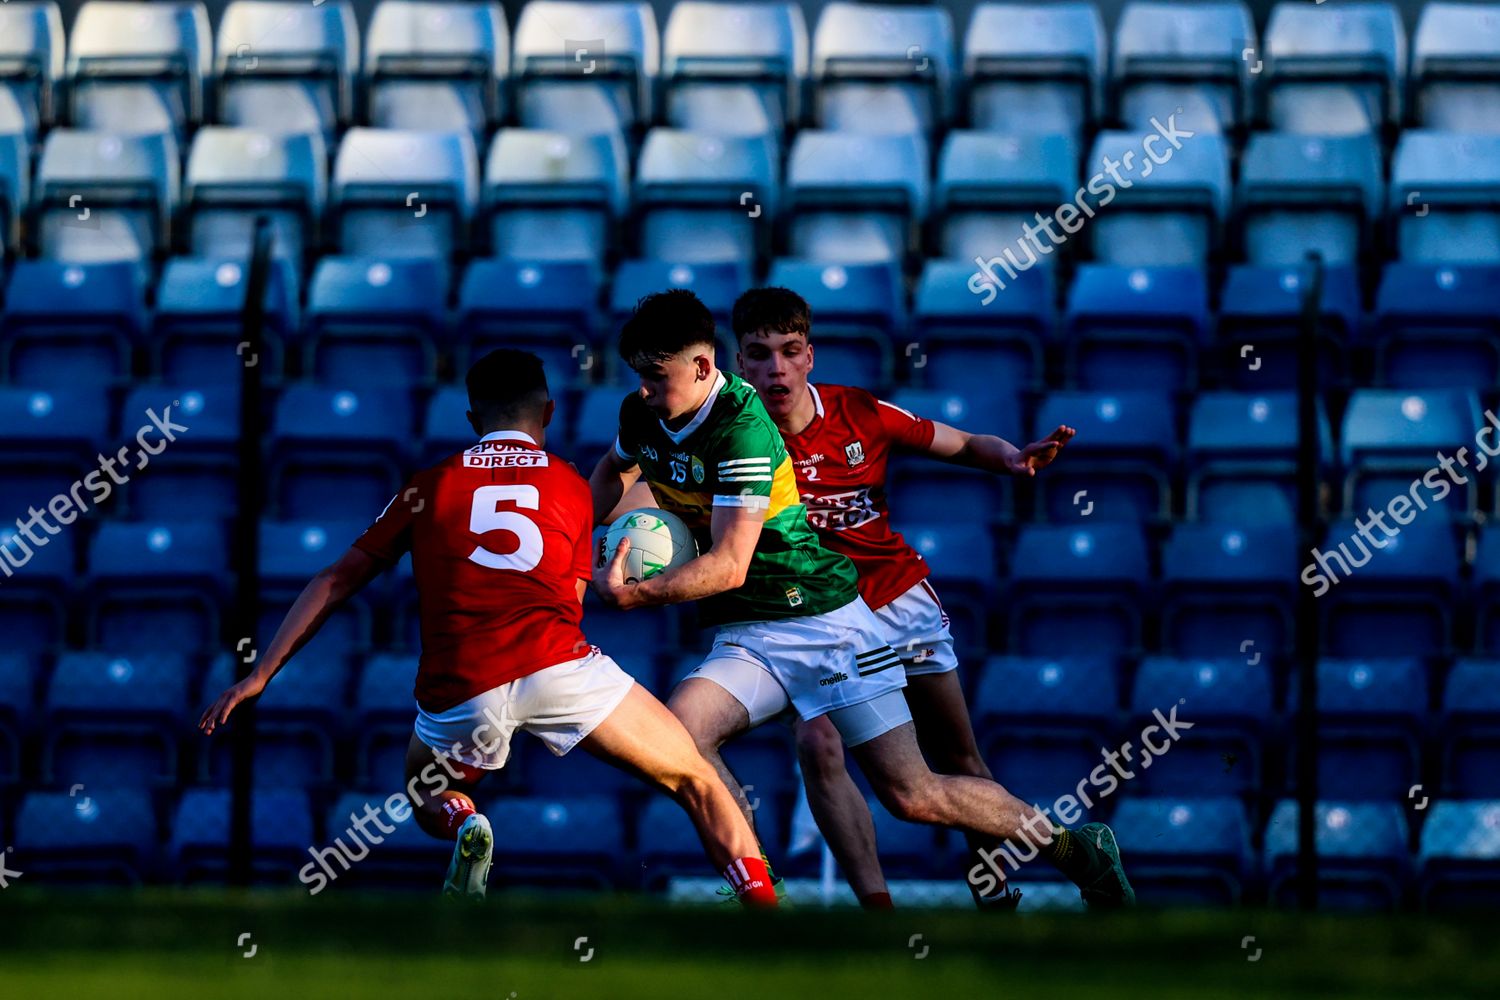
200,351,776,906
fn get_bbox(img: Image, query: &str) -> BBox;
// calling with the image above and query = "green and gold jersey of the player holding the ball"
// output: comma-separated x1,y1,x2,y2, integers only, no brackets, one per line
615,372,860,625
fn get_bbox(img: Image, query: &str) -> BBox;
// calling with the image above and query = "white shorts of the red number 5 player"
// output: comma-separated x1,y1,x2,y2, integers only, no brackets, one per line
416,646,635,771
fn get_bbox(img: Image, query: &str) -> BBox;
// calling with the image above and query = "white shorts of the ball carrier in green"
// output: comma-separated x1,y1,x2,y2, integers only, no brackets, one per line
684,598,912,747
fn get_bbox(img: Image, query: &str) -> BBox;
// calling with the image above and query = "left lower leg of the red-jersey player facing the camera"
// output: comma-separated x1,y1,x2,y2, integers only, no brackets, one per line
794,715,891,910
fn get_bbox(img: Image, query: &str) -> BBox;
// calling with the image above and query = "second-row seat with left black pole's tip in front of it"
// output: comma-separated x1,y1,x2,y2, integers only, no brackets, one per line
183,126,329,273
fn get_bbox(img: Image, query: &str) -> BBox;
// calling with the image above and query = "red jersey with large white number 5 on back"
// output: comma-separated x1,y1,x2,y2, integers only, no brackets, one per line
354,430,594,712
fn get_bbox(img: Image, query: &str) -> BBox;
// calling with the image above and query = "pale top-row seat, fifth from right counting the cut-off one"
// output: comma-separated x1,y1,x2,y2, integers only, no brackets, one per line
813,0,957,135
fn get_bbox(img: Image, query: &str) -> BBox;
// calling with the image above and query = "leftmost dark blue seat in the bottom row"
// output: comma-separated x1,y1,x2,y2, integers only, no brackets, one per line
9,789,156,885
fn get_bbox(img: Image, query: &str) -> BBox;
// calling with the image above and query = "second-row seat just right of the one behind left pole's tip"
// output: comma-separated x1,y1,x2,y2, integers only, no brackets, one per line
329,127,479,262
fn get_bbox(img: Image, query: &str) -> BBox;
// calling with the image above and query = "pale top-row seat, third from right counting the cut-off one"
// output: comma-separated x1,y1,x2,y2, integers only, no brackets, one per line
1110,0,1259,135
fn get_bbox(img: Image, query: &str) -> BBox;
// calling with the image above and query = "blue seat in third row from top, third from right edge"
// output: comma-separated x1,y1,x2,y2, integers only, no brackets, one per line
1064,264,1209,391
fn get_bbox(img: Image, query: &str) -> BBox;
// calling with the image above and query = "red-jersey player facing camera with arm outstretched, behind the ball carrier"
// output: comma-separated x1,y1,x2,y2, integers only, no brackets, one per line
734,288,1074,907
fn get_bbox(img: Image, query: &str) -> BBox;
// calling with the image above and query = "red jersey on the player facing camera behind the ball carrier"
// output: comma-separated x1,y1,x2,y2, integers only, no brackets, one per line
783,384,933,609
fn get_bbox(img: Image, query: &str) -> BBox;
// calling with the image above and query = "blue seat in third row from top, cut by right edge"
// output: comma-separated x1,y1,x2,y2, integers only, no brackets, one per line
1373,261,1500,390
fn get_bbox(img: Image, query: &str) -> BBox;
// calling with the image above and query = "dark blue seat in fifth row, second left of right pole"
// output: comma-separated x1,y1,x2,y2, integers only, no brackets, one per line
1008,523,1151,657
